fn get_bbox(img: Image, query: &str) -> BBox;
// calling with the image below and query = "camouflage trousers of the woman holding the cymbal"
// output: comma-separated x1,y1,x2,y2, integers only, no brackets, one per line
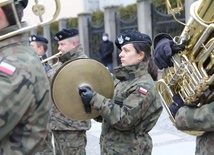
100,132,153,155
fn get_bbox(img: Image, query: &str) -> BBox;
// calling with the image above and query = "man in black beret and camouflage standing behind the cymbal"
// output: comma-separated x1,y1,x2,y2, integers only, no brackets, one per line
46,28,91,155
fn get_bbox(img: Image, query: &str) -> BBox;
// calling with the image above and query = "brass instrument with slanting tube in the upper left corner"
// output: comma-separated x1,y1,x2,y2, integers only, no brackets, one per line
0,0,60,40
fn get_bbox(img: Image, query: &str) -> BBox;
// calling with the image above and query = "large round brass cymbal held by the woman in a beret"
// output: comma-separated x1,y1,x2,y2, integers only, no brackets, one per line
51,58,114,120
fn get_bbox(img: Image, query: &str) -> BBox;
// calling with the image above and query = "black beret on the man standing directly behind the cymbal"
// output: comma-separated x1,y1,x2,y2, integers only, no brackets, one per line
54,28,79,41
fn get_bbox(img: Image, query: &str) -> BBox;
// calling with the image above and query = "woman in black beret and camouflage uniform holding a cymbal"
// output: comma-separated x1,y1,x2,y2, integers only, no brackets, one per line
79,30,162,155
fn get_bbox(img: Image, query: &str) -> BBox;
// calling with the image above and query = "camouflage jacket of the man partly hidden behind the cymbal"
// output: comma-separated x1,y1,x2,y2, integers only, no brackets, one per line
49,46,91,130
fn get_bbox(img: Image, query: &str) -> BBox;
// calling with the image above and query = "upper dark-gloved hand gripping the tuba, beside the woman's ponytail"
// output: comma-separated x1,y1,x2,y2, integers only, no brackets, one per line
154,38,181,69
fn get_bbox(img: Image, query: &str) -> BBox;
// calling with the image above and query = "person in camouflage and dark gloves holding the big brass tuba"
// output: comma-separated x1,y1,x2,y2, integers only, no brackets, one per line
154,34,214,155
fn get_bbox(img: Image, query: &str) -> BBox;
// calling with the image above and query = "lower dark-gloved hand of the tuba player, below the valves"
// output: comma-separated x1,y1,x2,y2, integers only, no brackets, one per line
169,94,184,118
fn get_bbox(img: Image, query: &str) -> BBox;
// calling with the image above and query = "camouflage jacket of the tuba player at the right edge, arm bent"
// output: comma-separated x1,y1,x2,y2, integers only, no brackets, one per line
175,101,214,155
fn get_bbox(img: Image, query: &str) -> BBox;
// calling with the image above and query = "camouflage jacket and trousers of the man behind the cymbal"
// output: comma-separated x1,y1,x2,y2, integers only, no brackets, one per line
41,46,91,155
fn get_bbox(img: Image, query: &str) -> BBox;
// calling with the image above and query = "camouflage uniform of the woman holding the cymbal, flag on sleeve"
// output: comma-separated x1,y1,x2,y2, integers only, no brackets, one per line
90,62,162,155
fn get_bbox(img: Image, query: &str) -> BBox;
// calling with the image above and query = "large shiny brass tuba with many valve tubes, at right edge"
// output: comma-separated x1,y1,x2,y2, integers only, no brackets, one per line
157,0,214,136
